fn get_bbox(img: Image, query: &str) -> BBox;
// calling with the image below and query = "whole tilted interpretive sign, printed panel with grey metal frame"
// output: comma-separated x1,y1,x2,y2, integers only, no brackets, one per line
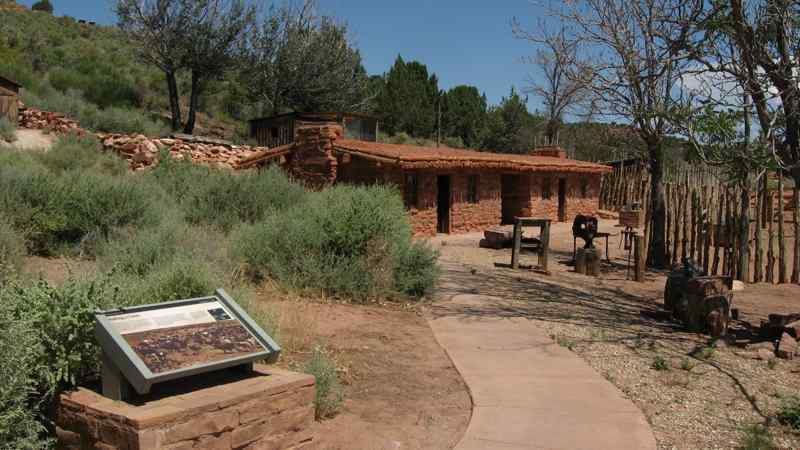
95,289,280,398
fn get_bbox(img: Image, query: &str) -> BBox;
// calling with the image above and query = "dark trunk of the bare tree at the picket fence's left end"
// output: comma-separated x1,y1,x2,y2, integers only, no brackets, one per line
647,140,667,269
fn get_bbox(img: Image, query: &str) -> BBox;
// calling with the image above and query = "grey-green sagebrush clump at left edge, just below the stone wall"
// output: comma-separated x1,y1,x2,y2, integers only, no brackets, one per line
0,140,158,255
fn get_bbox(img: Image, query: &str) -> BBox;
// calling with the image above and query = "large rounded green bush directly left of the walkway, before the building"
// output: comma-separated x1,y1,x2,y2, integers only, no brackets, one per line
234,186,436,300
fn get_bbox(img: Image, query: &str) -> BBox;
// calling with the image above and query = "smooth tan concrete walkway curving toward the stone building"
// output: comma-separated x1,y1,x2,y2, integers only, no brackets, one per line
429,262,656,450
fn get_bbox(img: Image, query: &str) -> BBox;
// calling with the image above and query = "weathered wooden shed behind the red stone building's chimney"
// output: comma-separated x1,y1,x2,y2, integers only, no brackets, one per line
250,112,378,148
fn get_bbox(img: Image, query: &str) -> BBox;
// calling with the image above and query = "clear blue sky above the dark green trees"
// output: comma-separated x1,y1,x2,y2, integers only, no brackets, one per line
18,0,543,111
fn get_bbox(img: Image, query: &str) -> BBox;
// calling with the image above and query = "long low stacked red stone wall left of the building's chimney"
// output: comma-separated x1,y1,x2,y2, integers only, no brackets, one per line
97,134,265,171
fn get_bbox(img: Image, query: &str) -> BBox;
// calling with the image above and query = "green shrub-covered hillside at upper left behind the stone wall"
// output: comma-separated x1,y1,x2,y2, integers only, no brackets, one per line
0,0,245,138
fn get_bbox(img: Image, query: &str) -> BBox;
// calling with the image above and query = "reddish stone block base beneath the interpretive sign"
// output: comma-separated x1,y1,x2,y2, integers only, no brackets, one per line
56,365,314,450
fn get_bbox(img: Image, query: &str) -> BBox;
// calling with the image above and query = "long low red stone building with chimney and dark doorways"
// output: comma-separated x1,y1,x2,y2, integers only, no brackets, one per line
256,123,611,235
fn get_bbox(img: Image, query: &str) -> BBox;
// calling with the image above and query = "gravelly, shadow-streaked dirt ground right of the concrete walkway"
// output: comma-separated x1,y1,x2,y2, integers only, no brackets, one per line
431,221,800,449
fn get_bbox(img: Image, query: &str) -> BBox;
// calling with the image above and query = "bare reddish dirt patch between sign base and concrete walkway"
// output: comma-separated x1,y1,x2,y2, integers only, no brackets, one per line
253,291,472,450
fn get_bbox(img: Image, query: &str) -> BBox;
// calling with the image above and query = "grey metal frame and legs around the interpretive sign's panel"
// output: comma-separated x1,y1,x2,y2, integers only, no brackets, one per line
95,289,281,400
